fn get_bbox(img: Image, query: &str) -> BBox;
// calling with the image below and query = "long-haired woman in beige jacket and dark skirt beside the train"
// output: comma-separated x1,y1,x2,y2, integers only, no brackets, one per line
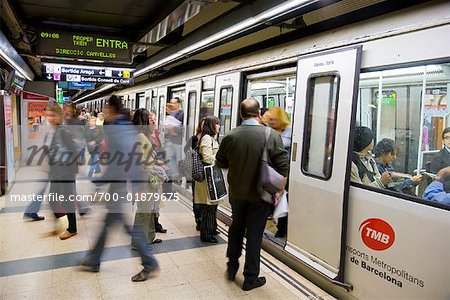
194,116,220,243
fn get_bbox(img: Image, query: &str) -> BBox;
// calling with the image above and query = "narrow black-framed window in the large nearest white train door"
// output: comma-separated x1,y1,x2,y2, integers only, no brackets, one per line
302,74,339,180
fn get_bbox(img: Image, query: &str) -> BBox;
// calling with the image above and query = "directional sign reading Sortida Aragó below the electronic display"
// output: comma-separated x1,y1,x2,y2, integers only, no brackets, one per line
42,63,134,88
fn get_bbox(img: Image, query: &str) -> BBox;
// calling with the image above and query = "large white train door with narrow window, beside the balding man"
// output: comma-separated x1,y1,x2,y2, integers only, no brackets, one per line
286,46,362,282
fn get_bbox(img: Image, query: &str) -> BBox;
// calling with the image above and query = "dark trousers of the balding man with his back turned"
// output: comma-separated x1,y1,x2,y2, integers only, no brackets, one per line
227,197,270,282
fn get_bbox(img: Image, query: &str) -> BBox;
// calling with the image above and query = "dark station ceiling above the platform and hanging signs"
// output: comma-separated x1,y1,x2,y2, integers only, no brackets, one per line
0,0,436,101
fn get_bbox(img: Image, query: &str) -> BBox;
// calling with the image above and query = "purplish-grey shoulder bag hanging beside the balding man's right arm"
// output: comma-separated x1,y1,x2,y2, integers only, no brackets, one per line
259,127,284,204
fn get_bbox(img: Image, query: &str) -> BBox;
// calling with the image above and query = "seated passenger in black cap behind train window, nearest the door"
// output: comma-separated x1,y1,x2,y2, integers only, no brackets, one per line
350,126,392,188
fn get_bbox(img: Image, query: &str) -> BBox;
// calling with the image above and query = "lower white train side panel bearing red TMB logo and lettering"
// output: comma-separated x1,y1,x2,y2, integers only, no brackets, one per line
345,188,450,299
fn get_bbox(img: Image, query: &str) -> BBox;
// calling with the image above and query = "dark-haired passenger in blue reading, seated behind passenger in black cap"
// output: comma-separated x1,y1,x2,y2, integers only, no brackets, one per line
375,139,422,196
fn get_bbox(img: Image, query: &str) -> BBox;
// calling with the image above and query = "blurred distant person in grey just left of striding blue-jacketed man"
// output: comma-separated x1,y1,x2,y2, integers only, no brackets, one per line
84,117,105,177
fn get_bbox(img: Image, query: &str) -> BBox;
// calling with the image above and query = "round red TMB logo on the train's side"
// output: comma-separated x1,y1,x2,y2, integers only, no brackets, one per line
359,218,395,251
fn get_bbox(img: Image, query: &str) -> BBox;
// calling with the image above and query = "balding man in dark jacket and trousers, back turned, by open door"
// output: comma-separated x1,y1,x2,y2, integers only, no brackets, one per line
216,99,289,291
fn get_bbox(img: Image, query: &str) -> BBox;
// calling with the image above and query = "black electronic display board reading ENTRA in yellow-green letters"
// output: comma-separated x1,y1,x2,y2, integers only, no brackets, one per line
37,30,132,63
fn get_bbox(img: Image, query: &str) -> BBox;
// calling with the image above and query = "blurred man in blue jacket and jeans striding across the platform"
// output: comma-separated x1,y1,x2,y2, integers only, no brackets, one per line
81,96,159,282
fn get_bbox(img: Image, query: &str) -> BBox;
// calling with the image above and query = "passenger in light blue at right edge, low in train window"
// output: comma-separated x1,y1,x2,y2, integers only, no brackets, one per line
423,167,450,205
